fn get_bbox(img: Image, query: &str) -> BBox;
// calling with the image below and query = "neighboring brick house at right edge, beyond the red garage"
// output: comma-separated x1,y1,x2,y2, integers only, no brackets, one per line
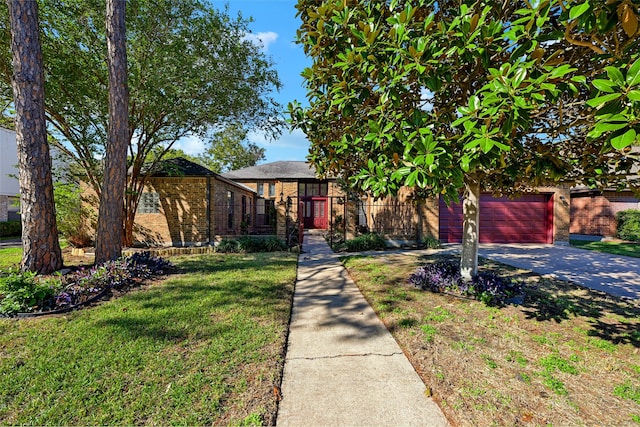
571,187,640,237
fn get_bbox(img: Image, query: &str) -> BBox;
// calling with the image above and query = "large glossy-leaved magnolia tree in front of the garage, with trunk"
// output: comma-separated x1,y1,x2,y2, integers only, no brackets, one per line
290,0,640,280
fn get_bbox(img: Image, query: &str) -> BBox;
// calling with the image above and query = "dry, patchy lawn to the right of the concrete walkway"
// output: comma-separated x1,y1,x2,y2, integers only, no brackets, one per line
344,254,640,426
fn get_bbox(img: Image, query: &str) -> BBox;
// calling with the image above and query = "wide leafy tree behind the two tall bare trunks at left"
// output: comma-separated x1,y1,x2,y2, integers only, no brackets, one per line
0,0,282,245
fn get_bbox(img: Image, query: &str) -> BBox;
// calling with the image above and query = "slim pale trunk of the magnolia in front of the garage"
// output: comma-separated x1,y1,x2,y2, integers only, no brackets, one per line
460,175,480,282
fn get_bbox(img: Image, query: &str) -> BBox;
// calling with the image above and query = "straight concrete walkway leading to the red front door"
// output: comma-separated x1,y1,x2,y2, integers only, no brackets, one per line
276,233,447,426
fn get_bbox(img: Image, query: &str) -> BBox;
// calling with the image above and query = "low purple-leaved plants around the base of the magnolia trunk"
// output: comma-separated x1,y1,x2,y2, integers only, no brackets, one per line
409,262,524,305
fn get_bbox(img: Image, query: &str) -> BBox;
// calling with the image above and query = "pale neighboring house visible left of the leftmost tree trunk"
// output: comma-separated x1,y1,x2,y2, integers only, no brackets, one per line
0,128,20,221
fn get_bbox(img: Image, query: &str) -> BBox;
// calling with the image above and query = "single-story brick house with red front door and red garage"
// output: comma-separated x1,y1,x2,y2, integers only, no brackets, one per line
127,159,570,246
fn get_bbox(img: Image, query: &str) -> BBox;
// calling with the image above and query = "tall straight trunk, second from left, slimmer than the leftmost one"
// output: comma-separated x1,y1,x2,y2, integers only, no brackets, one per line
96,0,129,264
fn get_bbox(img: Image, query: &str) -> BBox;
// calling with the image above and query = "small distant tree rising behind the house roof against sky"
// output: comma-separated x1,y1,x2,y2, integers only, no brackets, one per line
198,123,265,173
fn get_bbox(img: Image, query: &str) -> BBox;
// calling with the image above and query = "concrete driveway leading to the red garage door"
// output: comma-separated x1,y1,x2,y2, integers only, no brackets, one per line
479,244,640,299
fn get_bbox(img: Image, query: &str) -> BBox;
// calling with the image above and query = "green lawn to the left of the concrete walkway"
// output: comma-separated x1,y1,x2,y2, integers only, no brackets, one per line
0,253,296,425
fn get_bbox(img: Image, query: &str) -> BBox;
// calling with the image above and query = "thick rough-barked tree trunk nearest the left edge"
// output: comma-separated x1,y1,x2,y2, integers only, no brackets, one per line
7,0,62,274
